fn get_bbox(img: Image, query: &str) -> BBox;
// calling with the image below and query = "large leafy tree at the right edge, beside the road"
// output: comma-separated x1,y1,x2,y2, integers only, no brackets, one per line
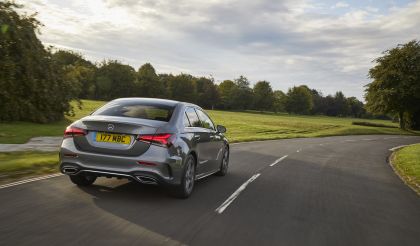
365,40,420,129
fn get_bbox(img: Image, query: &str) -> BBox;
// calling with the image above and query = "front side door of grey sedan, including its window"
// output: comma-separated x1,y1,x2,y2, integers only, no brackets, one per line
196,109,223,171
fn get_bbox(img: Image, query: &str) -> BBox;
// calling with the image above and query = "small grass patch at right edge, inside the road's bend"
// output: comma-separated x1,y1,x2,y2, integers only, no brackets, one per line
391,144,420,195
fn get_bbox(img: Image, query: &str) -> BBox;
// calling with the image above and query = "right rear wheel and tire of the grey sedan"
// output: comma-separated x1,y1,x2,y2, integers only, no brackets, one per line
172,155,196,199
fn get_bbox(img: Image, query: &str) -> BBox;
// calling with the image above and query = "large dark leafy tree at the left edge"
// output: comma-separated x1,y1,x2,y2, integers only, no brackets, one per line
0,1,74,122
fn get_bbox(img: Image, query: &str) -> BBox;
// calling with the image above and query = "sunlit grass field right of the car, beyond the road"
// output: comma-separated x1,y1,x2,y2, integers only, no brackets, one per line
208,110,411,142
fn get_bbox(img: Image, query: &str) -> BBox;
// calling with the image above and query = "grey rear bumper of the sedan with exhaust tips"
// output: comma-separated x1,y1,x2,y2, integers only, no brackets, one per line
60,138,183,185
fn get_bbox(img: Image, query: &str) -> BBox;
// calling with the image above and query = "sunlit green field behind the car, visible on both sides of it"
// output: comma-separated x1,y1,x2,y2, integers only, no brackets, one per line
0,100,412,143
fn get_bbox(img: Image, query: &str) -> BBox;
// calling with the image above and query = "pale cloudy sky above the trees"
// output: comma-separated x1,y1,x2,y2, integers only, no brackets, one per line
17,0,420,100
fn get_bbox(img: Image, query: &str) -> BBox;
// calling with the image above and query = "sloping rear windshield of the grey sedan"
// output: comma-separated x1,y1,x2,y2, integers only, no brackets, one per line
92,102,175,122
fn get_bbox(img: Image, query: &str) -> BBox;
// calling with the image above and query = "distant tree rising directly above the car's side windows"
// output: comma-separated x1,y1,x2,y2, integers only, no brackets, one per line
195,77,219,109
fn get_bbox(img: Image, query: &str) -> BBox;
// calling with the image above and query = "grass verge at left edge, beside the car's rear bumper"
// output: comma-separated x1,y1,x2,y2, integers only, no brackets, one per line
0,152,58,183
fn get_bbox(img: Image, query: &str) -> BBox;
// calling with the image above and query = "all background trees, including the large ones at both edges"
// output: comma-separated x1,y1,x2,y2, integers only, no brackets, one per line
0,2,420,129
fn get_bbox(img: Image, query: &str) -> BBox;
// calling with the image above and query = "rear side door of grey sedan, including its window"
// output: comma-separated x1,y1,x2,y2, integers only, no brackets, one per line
185,107,212,176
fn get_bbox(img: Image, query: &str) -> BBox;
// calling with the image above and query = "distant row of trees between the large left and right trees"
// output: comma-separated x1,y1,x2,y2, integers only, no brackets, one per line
52,50,366,117
